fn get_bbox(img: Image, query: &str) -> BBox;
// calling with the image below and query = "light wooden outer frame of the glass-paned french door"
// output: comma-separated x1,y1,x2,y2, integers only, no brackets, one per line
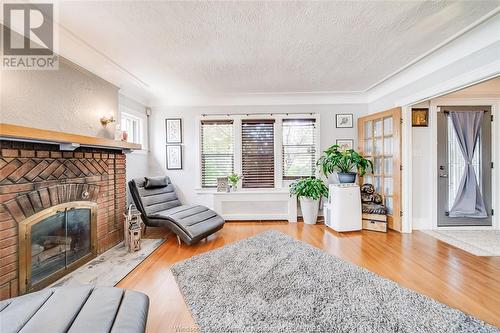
358,107,404,232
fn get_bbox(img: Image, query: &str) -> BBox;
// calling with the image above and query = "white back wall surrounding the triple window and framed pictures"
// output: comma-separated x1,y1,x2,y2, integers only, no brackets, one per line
149,104,368,207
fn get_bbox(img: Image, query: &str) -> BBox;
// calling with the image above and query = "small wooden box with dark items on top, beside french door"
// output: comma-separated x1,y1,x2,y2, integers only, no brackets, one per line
361,184,387,232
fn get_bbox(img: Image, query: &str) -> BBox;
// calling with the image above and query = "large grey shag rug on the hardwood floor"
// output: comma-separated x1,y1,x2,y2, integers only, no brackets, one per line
171,231,500,333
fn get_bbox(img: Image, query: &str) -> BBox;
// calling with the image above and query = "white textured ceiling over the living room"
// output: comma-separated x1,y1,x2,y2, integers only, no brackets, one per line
59,1,500,97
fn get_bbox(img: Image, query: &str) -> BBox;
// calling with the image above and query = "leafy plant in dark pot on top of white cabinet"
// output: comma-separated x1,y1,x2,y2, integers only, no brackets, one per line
316,145,373,183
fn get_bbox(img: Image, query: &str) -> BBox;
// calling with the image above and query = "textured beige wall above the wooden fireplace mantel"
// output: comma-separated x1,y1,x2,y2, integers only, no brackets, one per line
0,58,118,138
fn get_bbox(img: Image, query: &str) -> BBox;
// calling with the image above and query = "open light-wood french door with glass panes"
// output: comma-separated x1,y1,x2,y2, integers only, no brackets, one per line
358,108,402,231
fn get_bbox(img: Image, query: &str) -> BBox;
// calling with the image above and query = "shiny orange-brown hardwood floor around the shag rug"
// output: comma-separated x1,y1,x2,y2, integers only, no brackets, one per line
118,222,500,332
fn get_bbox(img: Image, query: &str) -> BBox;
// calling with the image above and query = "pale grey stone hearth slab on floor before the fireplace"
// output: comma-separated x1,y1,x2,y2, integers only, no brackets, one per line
50,239,165,287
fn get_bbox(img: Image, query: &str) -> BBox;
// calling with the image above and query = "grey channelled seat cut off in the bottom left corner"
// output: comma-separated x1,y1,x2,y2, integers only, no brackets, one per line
0,286,149,333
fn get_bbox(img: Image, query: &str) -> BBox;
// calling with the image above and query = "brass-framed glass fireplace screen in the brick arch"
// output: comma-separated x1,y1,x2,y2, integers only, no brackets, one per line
20,203,95,291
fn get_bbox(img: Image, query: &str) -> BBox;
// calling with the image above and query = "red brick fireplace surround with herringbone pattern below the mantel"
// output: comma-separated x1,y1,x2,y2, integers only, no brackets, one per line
0,141,126,300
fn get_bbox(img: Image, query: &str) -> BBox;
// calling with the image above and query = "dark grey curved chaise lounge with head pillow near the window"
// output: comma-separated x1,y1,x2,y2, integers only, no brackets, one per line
128,176,224,244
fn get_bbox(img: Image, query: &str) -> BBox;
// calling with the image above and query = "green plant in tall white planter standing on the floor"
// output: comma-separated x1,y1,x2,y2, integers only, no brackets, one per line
290,177,328,224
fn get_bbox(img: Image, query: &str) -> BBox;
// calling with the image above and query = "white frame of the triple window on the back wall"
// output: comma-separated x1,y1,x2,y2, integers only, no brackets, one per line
195,113,321,192
